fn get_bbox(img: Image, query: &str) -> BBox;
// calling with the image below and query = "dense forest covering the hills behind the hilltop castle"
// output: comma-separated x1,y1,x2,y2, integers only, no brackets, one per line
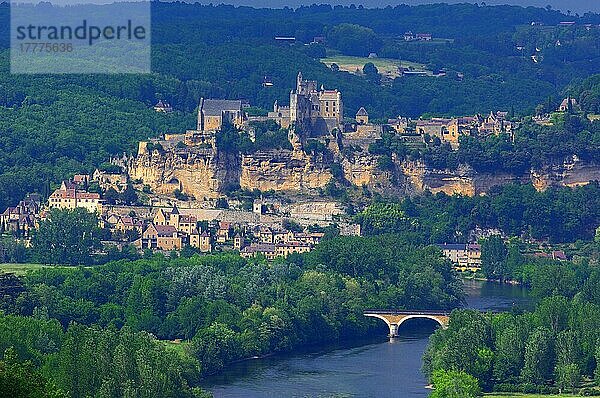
0,2,600,208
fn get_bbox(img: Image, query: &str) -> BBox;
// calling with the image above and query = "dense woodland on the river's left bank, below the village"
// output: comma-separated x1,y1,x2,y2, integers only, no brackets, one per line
0,235,463,398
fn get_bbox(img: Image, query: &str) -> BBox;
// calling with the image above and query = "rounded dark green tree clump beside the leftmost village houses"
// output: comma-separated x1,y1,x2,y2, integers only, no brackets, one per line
32,208,101,265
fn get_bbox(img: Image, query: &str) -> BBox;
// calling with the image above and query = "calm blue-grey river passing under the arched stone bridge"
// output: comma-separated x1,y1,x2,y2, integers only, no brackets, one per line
204,281,531,398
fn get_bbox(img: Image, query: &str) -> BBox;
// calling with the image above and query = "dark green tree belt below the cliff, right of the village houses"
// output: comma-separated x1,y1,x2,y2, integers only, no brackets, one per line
356,183,600,243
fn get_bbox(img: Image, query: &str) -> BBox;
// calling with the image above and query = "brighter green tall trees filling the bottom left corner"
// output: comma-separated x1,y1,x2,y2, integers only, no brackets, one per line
0,316,198,398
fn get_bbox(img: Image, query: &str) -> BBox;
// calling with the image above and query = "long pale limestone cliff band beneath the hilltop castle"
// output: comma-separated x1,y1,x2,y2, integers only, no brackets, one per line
121,137,600,199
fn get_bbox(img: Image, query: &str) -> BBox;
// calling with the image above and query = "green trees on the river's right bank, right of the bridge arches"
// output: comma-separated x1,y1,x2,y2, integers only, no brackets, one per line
424,244,600,398
